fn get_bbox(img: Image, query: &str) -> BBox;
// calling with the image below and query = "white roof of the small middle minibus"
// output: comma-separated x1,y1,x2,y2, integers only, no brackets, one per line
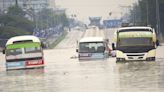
80,37,104,42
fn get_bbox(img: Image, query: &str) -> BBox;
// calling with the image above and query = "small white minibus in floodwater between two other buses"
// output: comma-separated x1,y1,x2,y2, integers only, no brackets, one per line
76,37,110,60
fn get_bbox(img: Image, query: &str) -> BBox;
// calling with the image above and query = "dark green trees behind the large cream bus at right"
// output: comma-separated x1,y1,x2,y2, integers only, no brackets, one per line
131,0,164,37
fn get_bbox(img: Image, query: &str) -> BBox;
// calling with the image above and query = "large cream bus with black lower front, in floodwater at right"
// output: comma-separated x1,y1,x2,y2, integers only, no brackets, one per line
112,27,156,62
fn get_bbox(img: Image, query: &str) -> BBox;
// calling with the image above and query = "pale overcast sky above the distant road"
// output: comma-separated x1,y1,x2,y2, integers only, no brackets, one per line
55,0,137,22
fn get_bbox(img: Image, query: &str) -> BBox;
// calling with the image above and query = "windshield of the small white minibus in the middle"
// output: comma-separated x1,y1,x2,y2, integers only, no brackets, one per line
79,42,105,53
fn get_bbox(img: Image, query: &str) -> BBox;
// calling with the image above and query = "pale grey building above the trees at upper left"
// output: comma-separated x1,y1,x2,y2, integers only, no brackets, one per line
0,0,49,12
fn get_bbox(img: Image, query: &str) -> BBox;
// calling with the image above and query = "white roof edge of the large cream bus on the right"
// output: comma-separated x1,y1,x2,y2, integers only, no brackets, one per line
118,26,153,32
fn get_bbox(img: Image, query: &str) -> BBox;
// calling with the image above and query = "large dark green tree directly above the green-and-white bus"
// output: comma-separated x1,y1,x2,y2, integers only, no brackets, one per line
0,6,34,38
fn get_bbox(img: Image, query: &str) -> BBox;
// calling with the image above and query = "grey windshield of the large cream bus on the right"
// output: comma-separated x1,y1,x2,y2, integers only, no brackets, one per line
118,38,153,46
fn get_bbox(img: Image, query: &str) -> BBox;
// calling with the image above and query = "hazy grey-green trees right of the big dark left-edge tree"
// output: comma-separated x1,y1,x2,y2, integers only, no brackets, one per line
36,8,68,28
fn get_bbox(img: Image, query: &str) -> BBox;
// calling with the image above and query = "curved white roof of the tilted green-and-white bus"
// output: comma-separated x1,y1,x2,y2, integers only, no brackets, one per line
6,35,40,45
